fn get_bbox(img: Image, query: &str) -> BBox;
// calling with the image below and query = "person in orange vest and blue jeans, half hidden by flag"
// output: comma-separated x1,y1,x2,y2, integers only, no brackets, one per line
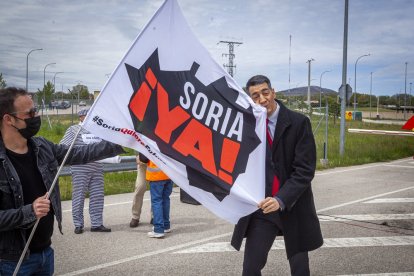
139,154,173,239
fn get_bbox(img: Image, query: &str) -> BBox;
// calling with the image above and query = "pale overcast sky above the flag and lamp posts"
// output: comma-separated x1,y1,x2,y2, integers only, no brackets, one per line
0,0,414,95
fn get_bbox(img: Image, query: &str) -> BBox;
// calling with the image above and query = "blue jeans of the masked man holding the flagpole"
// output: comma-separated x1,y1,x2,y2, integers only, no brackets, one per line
0,246,55,276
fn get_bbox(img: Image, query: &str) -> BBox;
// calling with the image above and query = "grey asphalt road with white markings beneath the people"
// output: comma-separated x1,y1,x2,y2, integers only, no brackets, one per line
53,158,414,275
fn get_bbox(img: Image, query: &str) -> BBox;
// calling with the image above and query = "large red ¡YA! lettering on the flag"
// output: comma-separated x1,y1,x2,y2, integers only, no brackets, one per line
130,68,240,185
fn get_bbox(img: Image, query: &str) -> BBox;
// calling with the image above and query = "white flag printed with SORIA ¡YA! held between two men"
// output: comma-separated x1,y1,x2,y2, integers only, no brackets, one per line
83,0,266,223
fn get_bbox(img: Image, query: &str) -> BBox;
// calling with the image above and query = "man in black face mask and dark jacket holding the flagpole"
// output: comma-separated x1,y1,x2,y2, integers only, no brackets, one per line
0,87,124,275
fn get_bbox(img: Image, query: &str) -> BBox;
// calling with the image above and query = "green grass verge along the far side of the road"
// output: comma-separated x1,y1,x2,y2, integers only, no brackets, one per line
39,115,414,200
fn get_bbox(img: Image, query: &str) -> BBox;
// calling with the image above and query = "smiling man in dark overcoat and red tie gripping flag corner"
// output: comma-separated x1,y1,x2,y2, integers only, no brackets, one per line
231,75,323,276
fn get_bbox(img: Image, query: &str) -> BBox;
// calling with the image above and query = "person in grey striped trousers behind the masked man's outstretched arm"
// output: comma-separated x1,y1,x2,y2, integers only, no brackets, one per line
60,109,111,234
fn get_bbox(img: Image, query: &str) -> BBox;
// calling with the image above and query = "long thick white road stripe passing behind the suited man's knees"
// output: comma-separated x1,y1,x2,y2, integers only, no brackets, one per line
172,236,414,254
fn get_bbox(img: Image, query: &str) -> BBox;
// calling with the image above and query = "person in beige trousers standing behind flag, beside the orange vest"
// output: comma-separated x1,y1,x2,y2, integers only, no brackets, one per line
129,153,148,228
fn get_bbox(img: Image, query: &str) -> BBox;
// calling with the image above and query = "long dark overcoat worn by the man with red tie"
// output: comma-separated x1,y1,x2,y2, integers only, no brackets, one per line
231,101,323,258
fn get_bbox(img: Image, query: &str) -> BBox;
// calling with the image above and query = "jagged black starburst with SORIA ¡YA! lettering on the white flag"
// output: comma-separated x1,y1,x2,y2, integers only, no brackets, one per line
125,50,260,201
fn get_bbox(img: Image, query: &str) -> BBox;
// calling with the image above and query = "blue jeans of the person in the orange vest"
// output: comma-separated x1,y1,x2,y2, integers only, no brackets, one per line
150,180,173,233
